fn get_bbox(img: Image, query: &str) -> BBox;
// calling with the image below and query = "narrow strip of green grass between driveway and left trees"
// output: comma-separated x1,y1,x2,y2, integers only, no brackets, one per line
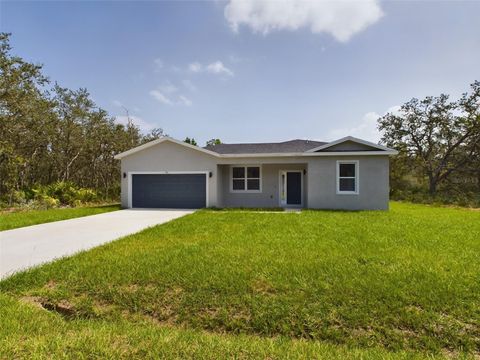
0,205,120,231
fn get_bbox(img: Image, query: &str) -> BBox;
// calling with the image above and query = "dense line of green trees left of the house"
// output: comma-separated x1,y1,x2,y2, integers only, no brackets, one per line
0,33,148,204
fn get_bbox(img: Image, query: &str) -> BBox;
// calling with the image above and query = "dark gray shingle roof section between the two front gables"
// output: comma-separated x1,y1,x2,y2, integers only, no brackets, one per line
204,139,326,154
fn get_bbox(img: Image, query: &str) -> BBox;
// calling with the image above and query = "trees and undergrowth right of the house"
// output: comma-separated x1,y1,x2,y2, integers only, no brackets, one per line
378,81,480,206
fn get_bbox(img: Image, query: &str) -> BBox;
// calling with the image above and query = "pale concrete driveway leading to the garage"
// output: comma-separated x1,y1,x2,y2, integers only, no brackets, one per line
0,209,194,279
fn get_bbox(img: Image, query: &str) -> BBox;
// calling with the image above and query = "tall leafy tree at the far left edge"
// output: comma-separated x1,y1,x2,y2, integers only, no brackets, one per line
0,33,53,202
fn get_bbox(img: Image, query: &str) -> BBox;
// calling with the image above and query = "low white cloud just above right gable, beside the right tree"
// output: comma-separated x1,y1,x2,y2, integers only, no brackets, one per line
327,105,400,143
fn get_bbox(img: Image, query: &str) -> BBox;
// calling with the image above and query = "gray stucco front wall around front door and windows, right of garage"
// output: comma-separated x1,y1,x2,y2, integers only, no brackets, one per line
219,156,389,210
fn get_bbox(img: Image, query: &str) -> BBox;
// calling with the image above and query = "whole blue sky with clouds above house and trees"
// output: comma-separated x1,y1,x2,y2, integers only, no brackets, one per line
0,0,480,143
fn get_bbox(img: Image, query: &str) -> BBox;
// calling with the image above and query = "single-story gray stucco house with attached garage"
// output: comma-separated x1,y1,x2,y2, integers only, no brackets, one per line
115,136,397,210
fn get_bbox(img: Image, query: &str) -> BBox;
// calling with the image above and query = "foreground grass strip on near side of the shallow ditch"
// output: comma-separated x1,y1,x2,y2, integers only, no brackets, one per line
0,294,434,360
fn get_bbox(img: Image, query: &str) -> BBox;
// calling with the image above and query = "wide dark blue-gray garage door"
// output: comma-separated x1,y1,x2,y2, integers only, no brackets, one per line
132,174,206,209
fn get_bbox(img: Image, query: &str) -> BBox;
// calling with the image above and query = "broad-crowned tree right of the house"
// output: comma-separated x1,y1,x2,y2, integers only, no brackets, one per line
378,81,480,195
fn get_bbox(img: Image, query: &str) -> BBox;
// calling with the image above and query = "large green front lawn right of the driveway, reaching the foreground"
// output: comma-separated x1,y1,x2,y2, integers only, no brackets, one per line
0,203,480,358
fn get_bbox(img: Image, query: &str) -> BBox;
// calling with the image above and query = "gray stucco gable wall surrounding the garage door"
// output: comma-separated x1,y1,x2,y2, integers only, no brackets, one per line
121,141,218,208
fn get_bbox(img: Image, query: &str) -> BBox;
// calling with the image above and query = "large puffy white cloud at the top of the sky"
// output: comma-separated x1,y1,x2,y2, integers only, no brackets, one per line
224,0,383,42
